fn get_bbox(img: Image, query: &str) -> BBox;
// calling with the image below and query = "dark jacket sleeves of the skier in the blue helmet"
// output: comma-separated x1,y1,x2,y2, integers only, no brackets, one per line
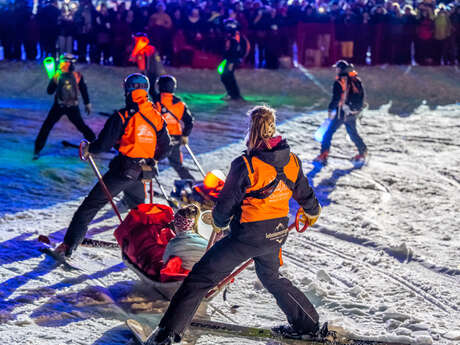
89,108,171,161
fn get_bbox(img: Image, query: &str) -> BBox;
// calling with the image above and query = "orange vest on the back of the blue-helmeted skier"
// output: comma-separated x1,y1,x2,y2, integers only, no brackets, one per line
118,101,164,159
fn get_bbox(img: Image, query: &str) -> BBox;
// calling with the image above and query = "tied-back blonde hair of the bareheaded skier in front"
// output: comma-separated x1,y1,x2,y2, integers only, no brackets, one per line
246,105,276,154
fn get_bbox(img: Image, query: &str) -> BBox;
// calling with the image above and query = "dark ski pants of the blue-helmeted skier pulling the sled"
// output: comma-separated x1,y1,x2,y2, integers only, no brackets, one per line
64,158,145,252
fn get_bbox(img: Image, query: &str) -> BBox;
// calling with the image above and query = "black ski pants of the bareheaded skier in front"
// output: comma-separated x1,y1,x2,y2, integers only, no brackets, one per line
159,230,319,335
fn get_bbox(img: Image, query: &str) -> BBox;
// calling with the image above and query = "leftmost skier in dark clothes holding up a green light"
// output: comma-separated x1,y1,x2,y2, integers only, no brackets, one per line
33,54,96,160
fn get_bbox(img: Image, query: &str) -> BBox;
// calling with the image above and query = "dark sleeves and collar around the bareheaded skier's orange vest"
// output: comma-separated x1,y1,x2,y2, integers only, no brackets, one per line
212,140,319,227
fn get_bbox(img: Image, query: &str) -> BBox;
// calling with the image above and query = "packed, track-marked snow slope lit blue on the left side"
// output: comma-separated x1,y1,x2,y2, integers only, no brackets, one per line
0,64,460,345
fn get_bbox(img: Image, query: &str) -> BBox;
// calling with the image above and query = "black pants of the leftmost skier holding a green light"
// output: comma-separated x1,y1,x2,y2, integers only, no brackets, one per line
35,103,96,154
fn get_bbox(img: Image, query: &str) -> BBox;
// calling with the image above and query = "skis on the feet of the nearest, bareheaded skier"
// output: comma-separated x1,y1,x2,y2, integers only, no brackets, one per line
126,319,407,345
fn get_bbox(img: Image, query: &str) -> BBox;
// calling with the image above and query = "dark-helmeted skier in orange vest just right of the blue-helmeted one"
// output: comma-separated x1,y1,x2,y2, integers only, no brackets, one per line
154,75,195,180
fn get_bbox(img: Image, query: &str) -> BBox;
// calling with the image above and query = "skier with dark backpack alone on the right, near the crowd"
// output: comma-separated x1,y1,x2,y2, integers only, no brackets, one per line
315,60,367,165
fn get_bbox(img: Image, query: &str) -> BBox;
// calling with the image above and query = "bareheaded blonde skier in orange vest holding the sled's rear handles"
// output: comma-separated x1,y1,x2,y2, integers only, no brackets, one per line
146,106,327,345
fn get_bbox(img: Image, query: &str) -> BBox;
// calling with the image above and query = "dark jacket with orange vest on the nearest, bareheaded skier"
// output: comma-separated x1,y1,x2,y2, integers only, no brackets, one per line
212,138,319,228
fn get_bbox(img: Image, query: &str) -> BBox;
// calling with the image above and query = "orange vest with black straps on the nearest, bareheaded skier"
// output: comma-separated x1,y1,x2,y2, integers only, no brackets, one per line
240,153,300,223
